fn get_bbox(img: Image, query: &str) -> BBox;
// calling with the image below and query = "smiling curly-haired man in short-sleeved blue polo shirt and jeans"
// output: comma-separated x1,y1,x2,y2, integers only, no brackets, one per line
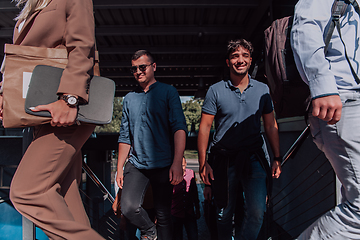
198,39,281,240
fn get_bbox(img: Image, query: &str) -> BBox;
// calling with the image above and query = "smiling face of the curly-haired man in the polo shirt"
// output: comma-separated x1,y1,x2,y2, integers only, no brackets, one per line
226,46,252,76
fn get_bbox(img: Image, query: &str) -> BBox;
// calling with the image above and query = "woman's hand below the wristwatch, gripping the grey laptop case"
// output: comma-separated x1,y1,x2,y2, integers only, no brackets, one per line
30,100,77,127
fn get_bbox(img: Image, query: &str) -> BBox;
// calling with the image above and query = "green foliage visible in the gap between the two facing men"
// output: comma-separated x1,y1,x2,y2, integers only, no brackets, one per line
182,99,204,131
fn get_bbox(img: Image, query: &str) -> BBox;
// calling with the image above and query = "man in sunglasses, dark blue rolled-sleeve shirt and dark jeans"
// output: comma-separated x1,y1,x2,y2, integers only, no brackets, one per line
116,50,186,240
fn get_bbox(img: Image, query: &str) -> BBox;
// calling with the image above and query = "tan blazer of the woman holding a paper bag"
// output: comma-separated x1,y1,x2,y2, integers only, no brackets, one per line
13,0,95,101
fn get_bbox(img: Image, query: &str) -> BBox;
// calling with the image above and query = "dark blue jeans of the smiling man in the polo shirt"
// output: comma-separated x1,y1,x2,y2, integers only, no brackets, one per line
217,155,267,240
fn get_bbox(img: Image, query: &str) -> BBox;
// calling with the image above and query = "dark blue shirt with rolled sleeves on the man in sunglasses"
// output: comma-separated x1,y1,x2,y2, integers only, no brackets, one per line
118,82,186,169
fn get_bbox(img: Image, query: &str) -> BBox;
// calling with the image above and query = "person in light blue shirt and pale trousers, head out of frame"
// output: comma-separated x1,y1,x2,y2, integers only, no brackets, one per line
291,0,360,240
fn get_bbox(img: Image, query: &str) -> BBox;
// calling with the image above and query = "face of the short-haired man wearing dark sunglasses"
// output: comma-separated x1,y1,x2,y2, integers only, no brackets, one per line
131,55,156,90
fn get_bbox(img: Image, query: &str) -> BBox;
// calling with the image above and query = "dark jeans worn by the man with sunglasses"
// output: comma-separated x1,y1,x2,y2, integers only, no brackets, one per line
121,162,173,240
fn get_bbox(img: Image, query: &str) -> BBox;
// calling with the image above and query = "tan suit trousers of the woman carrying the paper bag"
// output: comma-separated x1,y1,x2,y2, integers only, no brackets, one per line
10,124,103,240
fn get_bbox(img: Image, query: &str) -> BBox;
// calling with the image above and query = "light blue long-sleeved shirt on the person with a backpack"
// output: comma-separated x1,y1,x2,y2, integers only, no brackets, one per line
291,0,360,98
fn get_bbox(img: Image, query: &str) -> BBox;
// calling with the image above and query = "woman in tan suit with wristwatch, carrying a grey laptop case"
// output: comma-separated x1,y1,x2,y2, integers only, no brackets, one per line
0,0,103,239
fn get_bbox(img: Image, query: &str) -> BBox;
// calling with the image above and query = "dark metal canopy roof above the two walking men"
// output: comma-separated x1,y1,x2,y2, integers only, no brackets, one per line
0,0,297,96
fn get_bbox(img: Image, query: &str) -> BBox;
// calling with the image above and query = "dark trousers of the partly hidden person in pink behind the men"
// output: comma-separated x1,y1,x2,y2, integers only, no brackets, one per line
172,216,198,240
